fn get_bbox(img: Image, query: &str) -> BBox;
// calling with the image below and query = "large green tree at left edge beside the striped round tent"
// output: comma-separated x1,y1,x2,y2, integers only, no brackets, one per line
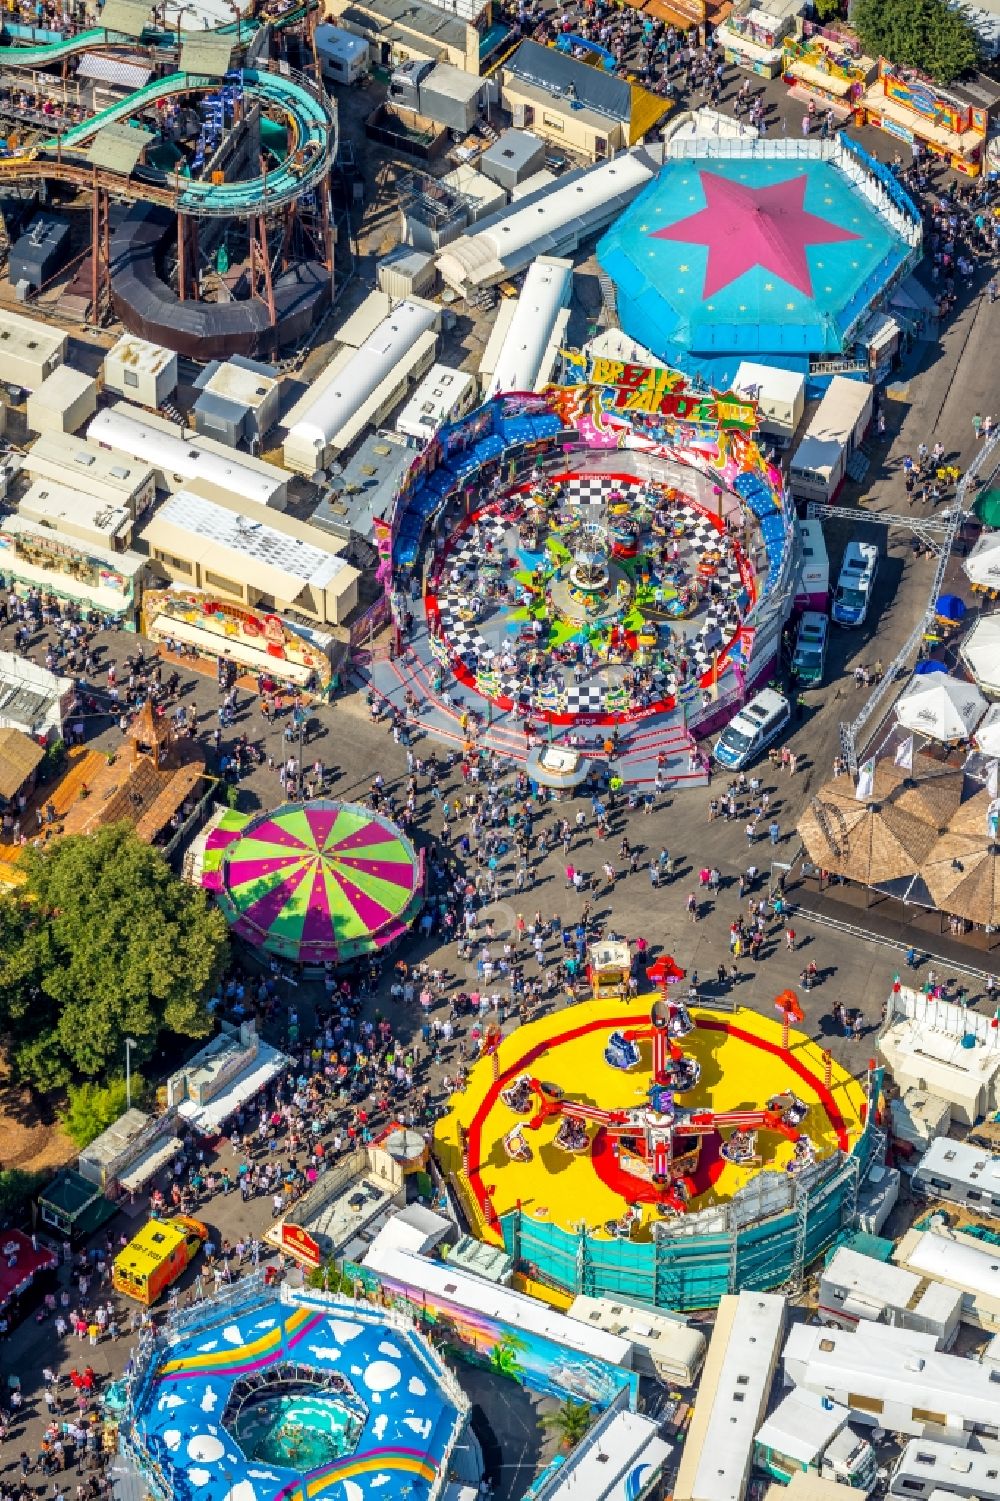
0,824,228,1088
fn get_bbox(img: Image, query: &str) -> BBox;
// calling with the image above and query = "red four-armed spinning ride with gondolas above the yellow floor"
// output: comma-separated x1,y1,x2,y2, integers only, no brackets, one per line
502,997,815,1235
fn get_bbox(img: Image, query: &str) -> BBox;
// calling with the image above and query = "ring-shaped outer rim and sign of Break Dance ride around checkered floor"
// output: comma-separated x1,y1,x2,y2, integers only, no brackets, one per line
378,366,800,732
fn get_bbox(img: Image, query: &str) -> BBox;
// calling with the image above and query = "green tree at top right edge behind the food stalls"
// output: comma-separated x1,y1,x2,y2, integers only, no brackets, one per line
853,0,979,84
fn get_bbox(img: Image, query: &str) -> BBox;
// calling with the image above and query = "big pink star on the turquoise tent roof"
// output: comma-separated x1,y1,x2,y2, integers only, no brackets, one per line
650,173,860,297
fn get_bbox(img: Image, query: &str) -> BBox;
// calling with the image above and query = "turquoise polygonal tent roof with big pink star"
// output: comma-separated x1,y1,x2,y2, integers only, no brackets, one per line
598,152,910,387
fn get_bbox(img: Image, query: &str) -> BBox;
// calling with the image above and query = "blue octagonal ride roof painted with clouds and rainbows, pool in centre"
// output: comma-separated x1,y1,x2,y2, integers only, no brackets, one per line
119,1274,468,1501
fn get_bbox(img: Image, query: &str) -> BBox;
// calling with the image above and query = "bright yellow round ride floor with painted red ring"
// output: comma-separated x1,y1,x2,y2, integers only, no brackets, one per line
434,995,866,1241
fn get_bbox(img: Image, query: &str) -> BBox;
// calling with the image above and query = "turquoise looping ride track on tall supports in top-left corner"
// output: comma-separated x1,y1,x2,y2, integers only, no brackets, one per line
0,6,336,219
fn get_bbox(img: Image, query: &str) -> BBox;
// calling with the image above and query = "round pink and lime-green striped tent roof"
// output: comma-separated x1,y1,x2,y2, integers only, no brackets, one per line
201,799,423,964
